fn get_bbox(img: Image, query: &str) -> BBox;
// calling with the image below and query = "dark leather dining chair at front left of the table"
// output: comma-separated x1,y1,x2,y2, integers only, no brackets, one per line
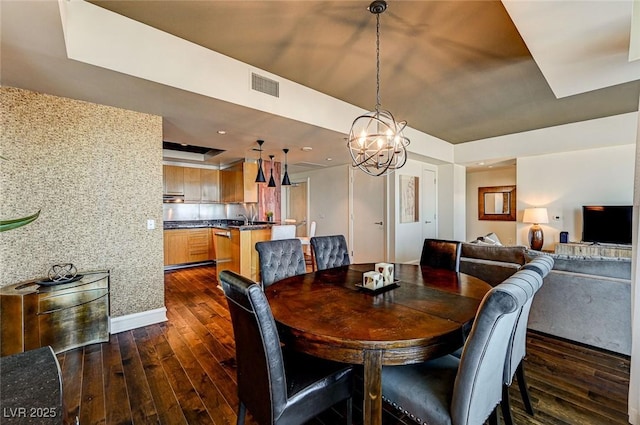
220,270,353,425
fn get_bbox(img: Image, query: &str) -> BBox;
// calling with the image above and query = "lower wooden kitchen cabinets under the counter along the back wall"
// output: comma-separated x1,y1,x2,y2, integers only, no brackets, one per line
164,228,214,266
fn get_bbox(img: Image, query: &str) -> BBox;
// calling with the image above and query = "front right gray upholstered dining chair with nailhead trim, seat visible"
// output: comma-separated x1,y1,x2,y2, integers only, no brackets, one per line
382,268,539,425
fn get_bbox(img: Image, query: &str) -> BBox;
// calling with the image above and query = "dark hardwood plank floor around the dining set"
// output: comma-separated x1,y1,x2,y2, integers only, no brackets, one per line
58,267,629,425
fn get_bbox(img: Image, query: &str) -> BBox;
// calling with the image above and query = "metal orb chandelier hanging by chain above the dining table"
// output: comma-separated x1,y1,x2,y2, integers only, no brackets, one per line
347,0,409,176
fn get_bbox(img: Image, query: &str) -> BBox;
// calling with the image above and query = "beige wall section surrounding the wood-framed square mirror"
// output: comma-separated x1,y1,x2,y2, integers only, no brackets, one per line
465,165,518,245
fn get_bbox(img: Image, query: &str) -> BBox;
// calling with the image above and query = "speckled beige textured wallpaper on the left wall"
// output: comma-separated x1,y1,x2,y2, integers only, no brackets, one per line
0,87,164,317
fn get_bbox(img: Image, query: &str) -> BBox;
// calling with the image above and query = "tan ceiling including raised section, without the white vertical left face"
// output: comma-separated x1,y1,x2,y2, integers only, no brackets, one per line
1,0,640,169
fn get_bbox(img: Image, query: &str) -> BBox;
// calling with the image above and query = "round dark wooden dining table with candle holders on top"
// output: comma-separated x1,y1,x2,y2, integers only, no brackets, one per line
265,263,491,425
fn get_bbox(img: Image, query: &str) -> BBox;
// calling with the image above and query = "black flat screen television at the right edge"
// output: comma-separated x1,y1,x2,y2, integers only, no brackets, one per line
582,205,633,245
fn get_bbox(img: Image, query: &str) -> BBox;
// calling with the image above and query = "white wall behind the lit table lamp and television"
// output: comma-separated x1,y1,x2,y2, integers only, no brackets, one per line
516,144,636,249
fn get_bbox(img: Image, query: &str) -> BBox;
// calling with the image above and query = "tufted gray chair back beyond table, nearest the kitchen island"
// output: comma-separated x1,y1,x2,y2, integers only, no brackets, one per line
256,239,307,287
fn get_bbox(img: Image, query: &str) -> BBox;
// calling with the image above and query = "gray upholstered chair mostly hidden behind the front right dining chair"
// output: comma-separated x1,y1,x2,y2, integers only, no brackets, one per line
500,255,554,425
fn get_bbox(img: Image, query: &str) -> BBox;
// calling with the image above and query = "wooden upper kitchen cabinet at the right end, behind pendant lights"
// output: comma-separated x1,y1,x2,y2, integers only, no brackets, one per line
220,162,258,203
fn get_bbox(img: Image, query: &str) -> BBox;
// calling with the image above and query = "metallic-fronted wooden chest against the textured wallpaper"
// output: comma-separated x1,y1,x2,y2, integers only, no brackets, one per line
0,271,109,356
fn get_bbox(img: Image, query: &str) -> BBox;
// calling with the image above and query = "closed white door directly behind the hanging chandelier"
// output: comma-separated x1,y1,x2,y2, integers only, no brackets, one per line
349,168,387,263
